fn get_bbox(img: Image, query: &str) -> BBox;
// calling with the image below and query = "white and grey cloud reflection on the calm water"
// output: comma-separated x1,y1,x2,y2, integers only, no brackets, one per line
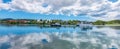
0,28,120,49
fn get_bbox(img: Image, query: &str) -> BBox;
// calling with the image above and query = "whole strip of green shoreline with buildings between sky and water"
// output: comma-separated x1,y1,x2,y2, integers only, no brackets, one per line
0,18,120,26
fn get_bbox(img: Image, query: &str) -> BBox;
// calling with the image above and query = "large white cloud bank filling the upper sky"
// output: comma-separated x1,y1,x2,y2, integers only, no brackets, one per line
0,0,120,20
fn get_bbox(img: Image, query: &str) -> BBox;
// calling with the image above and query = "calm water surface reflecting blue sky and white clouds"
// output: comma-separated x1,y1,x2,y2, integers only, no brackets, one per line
0,25,120,49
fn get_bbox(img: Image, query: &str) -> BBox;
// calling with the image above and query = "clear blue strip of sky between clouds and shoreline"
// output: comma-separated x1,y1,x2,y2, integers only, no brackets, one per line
0,10,93,21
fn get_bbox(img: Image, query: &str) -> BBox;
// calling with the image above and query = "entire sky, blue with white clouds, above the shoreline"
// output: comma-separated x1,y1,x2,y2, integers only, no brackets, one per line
0,0,120,21
